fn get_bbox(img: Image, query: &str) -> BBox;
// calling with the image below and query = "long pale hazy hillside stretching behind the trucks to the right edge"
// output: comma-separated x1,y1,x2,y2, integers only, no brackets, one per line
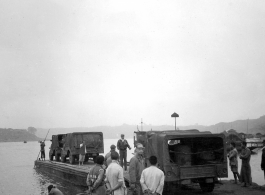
36,116,265,139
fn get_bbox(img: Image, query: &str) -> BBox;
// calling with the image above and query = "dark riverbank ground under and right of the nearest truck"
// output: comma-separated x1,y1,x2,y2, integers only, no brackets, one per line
176,180,265,195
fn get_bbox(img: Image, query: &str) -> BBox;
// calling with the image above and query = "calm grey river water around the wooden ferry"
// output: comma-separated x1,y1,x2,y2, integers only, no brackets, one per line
0,139,264,195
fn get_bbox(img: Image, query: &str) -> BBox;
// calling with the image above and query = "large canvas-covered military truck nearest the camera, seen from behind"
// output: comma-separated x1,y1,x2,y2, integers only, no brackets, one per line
134,129,228,194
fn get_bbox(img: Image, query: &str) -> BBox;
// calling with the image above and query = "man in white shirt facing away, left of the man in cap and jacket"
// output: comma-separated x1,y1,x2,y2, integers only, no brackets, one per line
105,152,125,195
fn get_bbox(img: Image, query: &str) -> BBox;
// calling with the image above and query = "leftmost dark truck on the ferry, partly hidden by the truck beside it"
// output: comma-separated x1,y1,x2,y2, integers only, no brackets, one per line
49,134,66,161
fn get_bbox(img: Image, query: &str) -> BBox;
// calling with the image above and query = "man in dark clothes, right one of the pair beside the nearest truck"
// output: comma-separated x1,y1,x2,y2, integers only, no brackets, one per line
239,141,252,187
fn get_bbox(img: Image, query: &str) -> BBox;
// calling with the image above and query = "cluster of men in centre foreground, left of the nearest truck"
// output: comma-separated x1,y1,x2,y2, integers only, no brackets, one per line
87,135,164,195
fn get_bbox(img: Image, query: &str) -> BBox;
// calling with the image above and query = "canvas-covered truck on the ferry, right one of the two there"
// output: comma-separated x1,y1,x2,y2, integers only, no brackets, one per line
61,132,104,164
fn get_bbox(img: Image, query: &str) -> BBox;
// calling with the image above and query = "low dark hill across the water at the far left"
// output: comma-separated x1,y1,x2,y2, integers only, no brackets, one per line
0,129,41,142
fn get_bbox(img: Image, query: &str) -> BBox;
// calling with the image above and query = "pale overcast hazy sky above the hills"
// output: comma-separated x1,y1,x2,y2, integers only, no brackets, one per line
0,0,265,128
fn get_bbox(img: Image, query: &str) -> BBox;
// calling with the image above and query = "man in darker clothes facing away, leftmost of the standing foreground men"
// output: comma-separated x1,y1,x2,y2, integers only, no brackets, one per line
86,155,106,195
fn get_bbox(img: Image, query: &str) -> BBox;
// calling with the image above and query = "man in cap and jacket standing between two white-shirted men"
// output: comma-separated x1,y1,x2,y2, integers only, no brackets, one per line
128,143,144,195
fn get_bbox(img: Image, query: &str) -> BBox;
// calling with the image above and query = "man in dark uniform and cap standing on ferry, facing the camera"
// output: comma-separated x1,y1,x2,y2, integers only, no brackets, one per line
117,134,131,171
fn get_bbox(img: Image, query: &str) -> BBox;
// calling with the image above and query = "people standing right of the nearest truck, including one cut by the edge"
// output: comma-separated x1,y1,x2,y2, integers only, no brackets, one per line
227,141,265,187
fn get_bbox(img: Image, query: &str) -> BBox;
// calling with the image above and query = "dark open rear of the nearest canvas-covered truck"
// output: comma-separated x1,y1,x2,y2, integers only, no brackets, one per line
168,137,224,166
